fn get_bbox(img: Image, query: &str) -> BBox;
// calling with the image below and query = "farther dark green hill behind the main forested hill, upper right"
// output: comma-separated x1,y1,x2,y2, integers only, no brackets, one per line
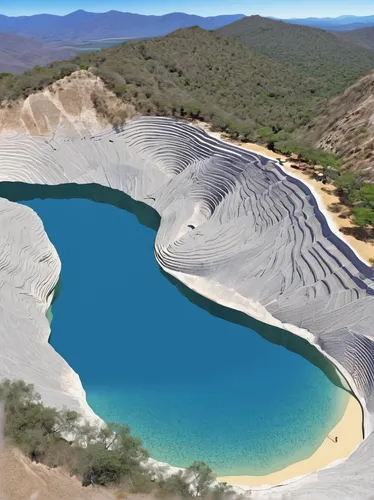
218,16,374,98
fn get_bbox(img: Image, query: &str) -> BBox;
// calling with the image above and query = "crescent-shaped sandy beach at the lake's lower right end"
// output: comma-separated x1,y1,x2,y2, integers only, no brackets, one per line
219,397,362,487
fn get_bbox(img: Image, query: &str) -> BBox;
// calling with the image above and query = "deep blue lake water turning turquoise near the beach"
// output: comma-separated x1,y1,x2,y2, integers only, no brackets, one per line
19,192,348,475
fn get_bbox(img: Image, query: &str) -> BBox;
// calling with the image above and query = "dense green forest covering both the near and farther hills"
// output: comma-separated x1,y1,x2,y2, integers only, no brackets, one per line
0,22,374,146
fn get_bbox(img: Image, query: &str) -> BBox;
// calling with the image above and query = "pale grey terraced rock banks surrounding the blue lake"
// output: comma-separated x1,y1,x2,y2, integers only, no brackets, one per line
0,117,374,499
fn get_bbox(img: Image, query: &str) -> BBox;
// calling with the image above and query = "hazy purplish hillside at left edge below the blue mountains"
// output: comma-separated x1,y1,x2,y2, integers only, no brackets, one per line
0,33,76,74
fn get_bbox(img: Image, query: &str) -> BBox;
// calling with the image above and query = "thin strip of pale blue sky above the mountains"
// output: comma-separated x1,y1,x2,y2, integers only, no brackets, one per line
0,0,374,18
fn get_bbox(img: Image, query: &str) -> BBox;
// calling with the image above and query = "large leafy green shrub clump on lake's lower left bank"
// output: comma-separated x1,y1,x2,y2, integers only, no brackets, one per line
0,380,148,491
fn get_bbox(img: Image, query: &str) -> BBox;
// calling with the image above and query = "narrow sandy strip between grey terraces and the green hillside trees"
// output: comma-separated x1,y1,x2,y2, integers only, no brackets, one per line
193,122,374,261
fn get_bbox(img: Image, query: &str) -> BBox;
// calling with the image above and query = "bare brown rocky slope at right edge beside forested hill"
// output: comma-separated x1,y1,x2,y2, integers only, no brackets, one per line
301,73,374,180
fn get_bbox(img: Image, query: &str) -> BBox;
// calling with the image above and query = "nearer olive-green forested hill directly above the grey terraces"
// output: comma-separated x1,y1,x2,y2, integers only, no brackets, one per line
0,27,322,140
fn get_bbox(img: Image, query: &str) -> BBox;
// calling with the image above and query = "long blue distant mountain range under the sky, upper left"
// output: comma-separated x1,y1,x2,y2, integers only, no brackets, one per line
0,10,244,43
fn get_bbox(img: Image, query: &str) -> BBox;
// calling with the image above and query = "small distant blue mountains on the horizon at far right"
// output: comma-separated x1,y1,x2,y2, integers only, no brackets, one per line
281,14,374,31
